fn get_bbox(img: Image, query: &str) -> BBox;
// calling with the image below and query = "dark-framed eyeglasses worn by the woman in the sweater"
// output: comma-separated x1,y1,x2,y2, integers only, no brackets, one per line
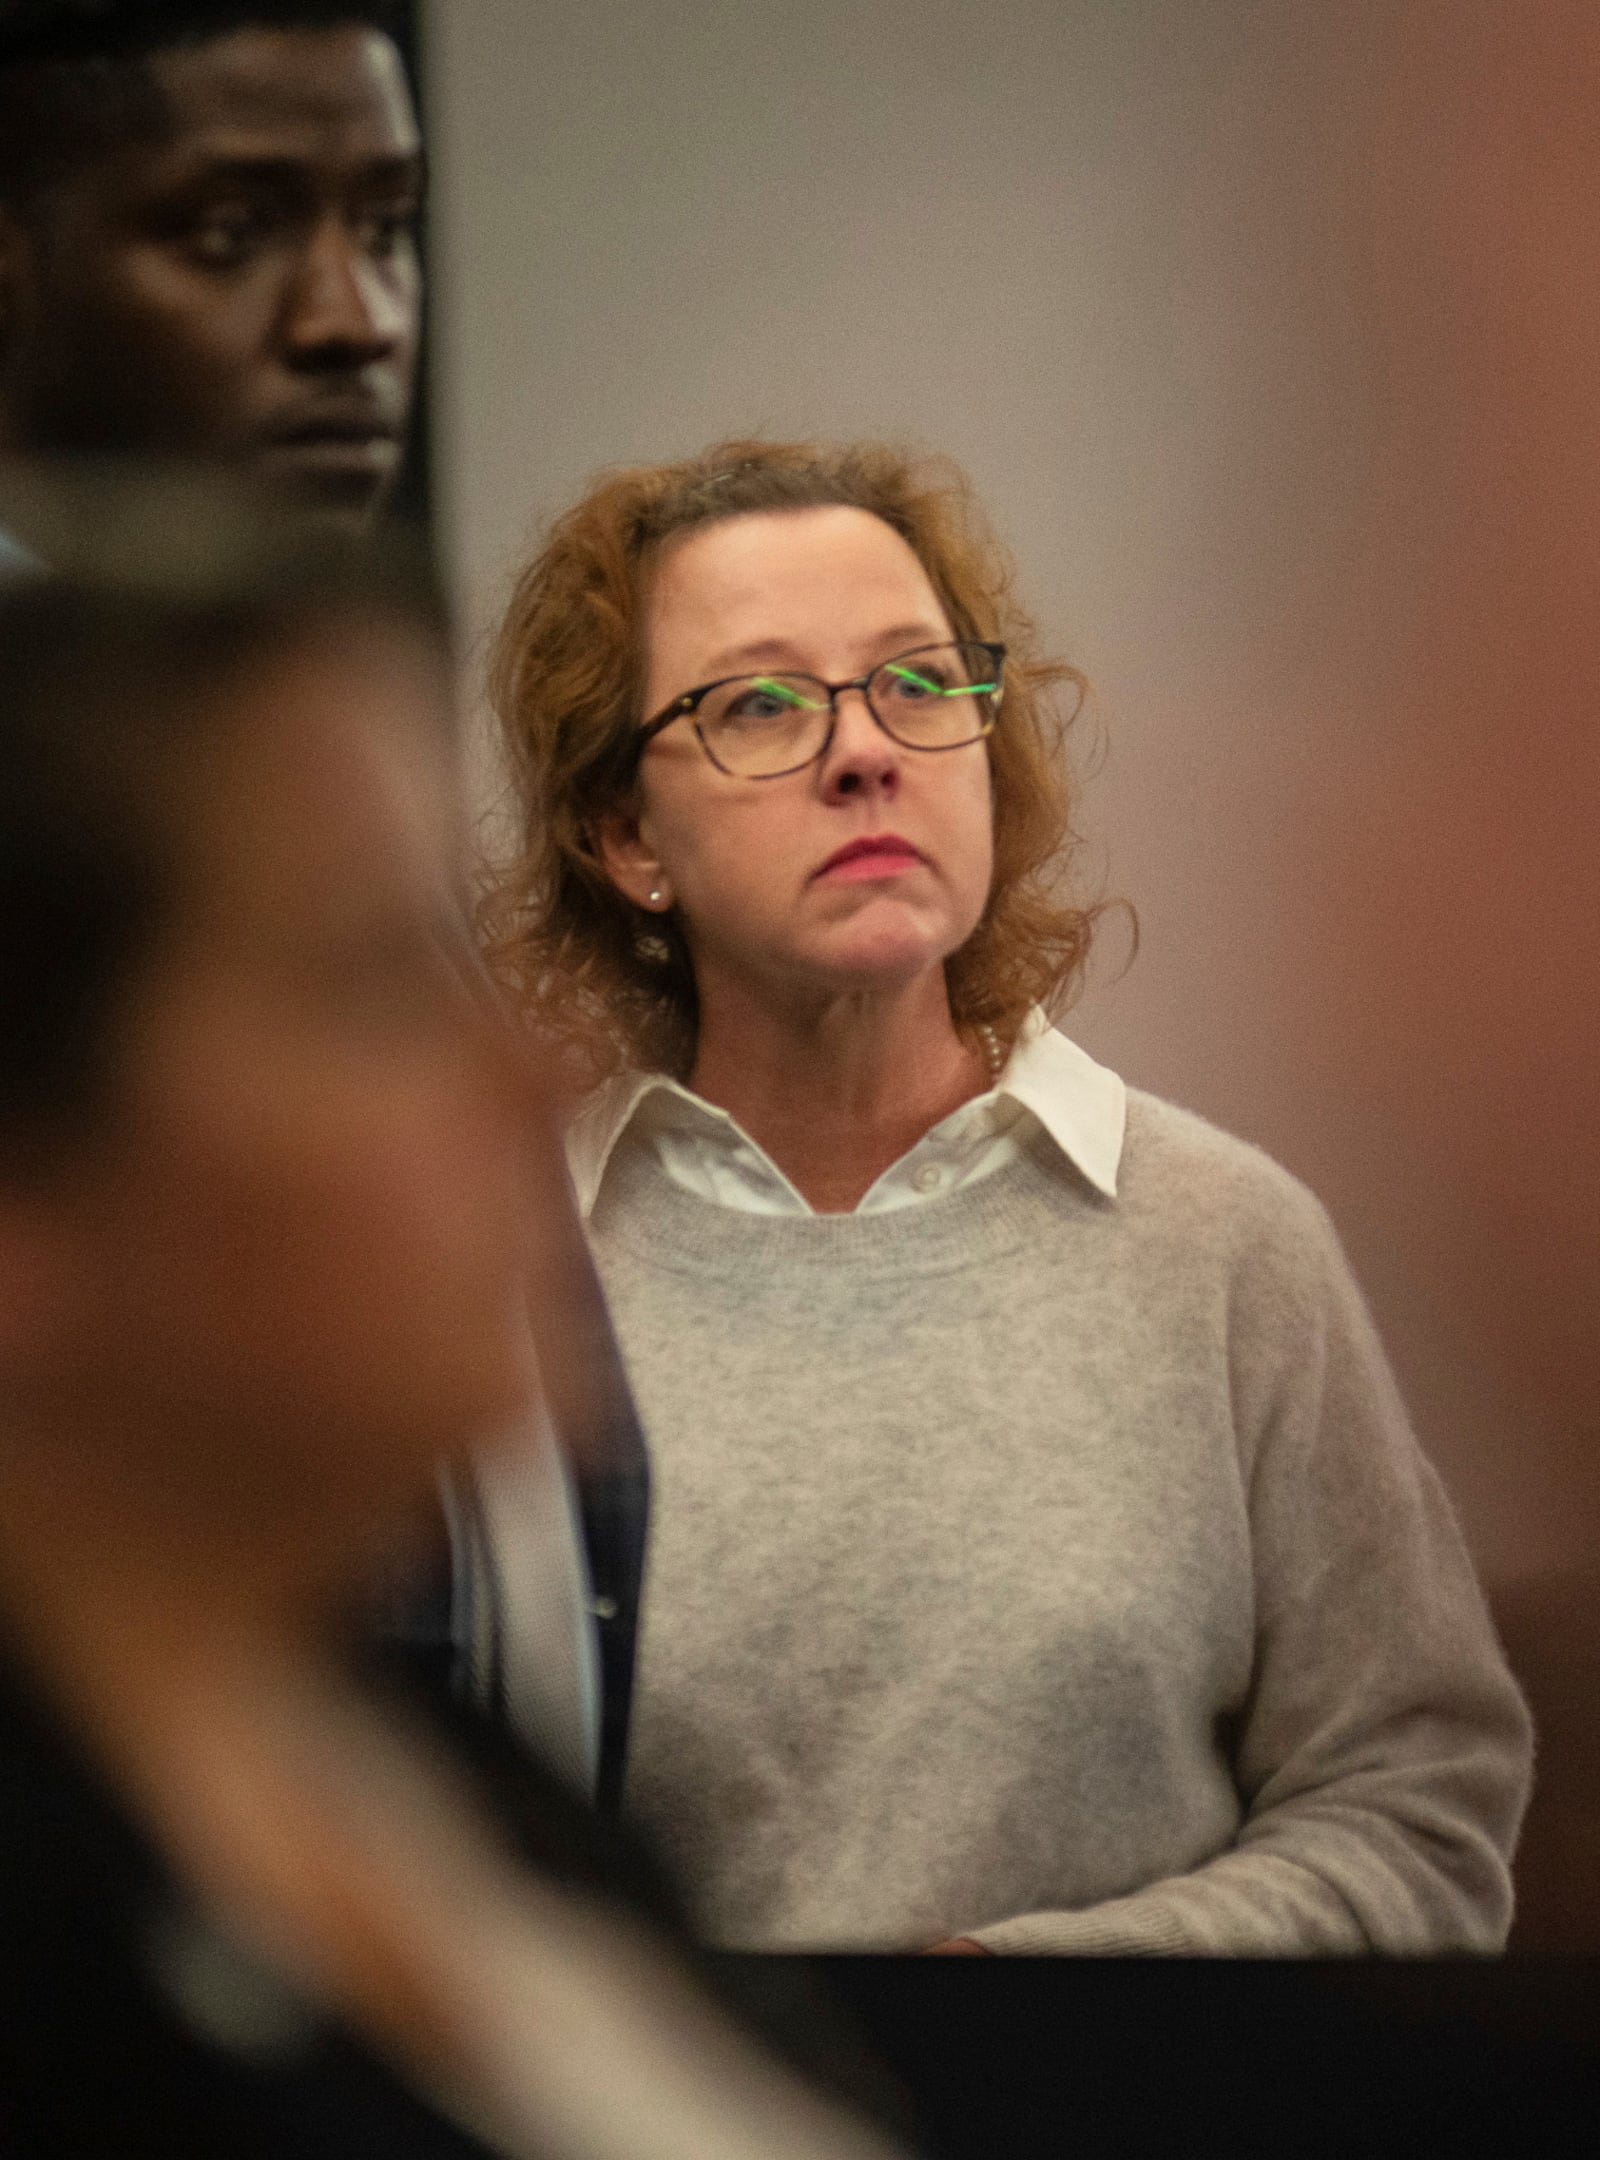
635,642,1006,780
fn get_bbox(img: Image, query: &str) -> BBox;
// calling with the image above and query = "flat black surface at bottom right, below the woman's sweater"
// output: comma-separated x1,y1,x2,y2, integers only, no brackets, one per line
726,1957,1600,2160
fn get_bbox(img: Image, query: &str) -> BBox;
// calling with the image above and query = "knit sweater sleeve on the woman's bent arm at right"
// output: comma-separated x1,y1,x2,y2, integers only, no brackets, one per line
974,1186,1531,1957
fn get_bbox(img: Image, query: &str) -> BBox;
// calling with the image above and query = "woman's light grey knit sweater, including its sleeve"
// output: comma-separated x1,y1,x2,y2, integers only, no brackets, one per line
592,1093,1529,1955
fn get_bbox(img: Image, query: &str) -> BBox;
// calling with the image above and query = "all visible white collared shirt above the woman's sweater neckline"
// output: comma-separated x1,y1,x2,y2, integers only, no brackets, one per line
566,1007,1127,1216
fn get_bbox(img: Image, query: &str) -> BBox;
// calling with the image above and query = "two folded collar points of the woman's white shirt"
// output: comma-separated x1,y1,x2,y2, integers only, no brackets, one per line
566,1007,1127,1218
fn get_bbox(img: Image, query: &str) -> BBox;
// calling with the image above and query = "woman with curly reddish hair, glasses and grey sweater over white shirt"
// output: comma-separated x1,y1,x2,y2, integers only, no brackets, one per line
488,441,1529,1955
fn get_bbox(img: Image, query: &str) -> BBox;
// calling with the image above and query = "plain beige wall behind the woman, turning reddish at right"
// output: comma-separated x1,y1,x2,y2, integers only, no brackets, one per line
434,0,1600,1944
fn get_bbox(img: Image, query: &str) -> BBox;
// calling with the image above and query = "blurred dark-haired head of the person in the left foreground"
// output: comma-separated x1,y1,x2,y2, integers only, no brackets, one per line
0,499,542,1607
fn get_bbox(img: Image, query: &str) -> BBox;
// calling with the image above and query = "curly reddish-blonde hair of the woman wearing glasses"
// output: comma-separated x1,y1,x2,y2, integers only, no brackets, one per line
479,441,1103,1082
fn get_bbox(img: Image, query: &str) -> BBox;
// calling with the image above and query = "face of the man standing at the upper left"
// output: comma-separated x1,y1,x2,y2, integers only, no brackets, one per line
0,26,423,516
